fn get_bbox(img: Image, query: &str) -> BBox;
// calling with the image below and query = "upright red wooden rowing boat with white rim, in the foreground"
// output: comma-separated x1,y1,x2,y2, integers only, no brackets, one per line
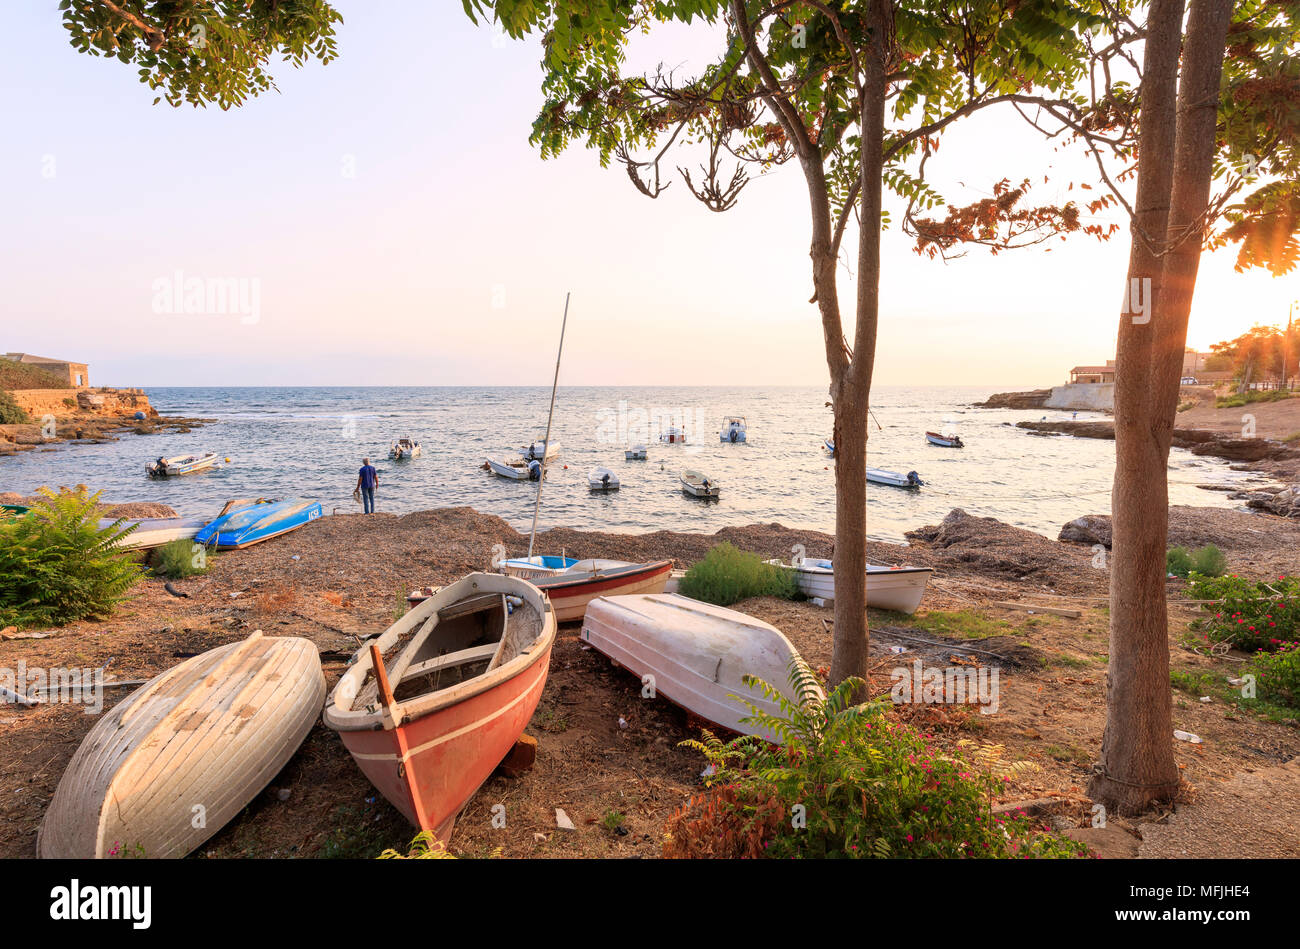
325,573,555,842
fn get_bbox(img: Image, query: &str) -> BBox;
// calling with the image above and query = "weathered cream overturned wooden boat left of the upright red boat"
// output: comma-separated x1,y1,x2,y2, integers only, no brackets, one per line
36,631,325,859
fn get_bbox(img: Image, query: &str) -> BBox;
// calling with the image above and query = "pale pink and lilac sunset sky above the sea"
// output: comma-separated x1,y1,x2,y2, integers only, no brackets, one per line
0,0,1300,387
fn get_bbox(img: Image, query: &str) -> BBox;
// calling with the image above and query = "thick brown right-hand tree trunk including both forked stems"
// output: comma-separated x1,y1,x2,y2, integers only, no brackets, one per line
1088,0,1231,814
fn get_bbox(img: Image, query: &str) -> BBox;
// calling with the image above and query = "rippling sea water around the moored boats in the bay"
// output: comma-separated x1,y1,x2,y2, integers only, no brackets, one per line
0,387,1245,543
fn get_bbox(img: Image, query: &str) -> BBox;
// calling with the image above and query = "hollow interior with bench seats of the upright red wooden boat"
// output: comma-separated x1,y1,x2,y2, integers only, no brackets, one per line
371,593,542,706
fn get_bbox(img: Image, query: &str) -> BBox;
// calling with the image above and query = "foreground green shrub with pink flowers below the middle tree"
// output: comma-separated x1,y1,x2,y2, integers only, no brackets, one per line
664,658,1088,858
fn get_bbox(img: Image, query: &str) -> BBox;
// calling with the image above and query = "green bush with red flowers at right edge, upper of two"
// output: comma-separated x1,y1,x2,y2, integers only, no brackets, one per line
1187,573,1300,651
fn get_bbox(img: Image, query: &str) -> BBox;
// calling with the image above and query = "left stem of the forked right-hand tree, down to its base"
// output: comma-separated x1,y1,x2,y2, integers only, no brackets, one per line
1088,0,1183,813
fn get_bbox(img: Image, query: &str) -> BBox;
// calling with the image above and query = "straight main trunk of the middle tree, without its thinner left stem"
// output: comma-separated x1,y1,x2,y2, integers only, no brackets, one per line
827,0,892,702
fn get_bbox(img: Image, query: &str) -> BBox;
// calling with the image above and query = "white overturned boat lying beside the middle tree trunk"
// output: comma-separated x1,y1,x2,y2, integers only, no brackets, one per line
581,593,820,741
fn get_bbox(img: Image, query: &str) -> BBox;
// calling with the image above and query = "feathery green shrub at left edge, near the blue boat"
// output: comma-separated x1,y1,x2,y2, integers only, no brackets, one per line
0,486,140,628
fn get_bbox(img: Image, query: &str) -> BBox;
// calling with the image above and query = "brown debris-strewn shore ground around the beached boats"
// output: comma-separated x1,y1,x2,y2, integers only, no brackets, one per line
0,508,1300,857
